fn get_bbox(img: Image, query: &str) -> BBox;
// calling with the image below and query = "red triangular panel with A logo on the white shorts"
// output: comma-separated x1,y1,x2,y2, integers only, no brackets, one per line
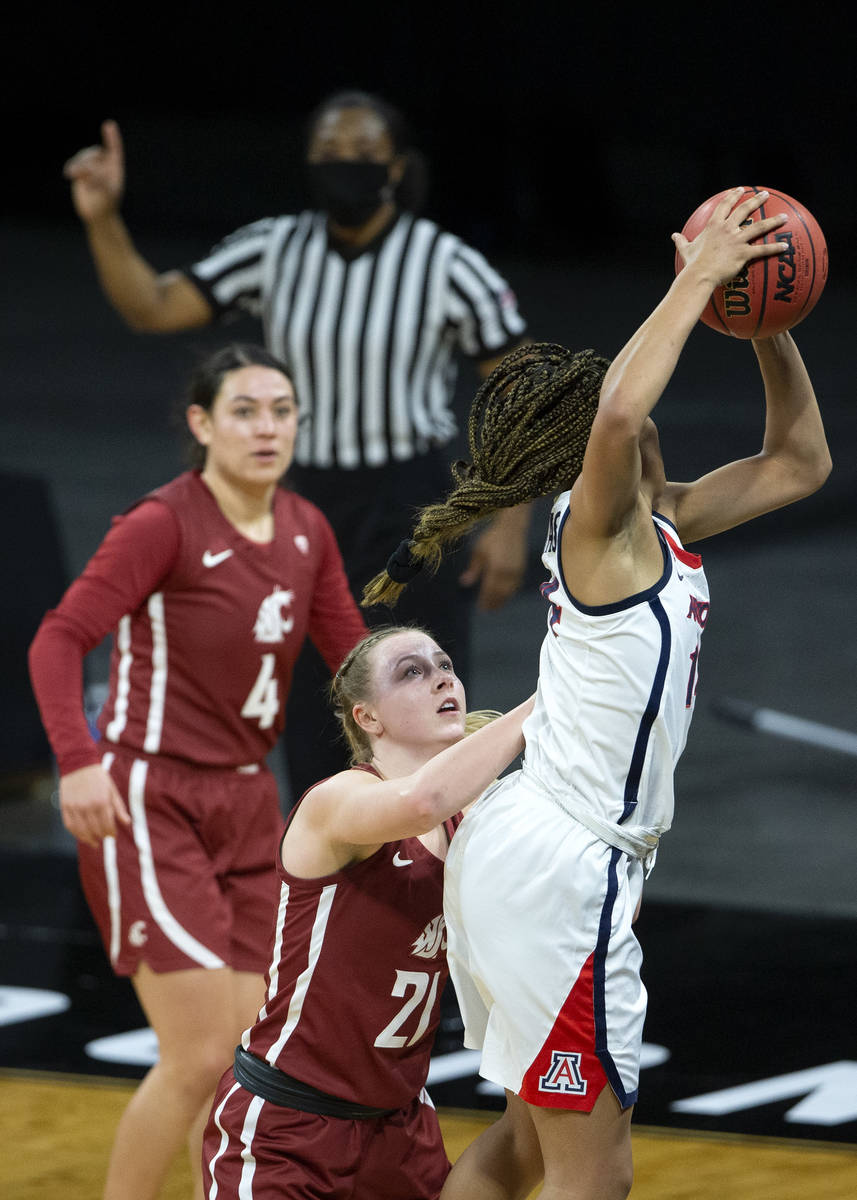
519,950,607,1112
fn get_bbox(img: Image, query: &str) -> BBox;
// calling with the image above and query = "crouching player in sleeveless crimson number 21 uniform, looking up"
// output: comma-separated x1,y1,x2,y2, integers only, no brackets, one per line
203,626,532,1200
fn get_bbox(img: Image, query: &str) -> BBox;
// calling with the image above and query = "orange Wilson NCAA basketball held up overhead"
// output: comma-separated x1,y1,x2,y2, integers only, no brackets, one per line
676,187,827,337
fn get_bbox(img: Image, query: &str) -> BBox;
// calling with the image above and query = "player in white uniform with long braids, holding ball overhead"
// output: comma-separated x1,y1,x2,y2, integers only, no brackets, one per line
357,188,831,1200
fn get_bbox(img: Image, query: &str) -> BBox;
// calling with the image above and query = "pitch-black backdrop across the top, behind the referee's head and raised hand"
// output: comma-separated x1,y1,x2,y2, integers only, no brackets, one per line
4,0,855,254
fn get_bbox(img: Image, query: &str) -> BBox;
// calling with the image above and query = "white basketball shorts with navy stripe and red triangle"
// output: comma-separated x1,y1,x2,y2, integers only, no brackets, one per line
444,773,646,1112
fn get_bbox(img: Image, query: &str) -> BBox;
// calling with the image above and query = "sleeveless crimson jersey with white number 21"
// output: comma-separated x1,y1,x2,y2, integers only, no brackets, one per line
241,768,459,1109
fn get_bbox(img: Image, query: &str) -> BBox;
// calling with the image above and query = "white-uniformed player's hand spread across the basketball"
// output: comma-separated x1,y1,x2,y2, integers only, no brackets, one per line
672,187,787,290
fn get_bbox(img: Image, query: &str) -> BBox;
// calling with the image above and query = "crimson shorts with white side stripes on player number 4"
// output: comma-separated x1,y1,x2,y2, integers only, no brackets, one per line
78,751,283,974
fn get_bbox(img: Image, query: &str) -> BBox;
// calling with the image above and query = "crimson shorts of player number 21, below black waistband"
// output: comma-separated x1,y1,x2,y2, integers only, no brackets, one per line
203,1068,449,1200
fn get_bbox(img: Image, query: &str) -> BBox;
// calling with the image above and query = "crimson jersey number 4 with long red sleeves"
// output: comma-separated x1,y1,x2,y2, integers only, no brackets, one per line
31,472,366,772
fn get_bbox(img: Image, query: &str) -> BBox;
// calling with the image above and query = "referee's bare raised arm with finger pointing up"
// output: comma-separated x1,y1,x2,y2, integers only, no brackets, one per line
64,121,212,332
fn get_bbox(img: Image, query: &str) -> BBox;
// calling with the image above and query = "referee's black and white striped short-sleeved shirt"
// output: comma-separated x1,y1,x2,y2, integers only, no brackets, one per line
188,211,526,468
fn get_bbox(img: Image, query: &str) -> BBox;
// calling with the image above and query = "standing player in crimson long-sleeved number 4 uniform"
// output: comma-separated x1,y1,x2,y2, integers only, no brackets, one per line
30,346,366,1200
